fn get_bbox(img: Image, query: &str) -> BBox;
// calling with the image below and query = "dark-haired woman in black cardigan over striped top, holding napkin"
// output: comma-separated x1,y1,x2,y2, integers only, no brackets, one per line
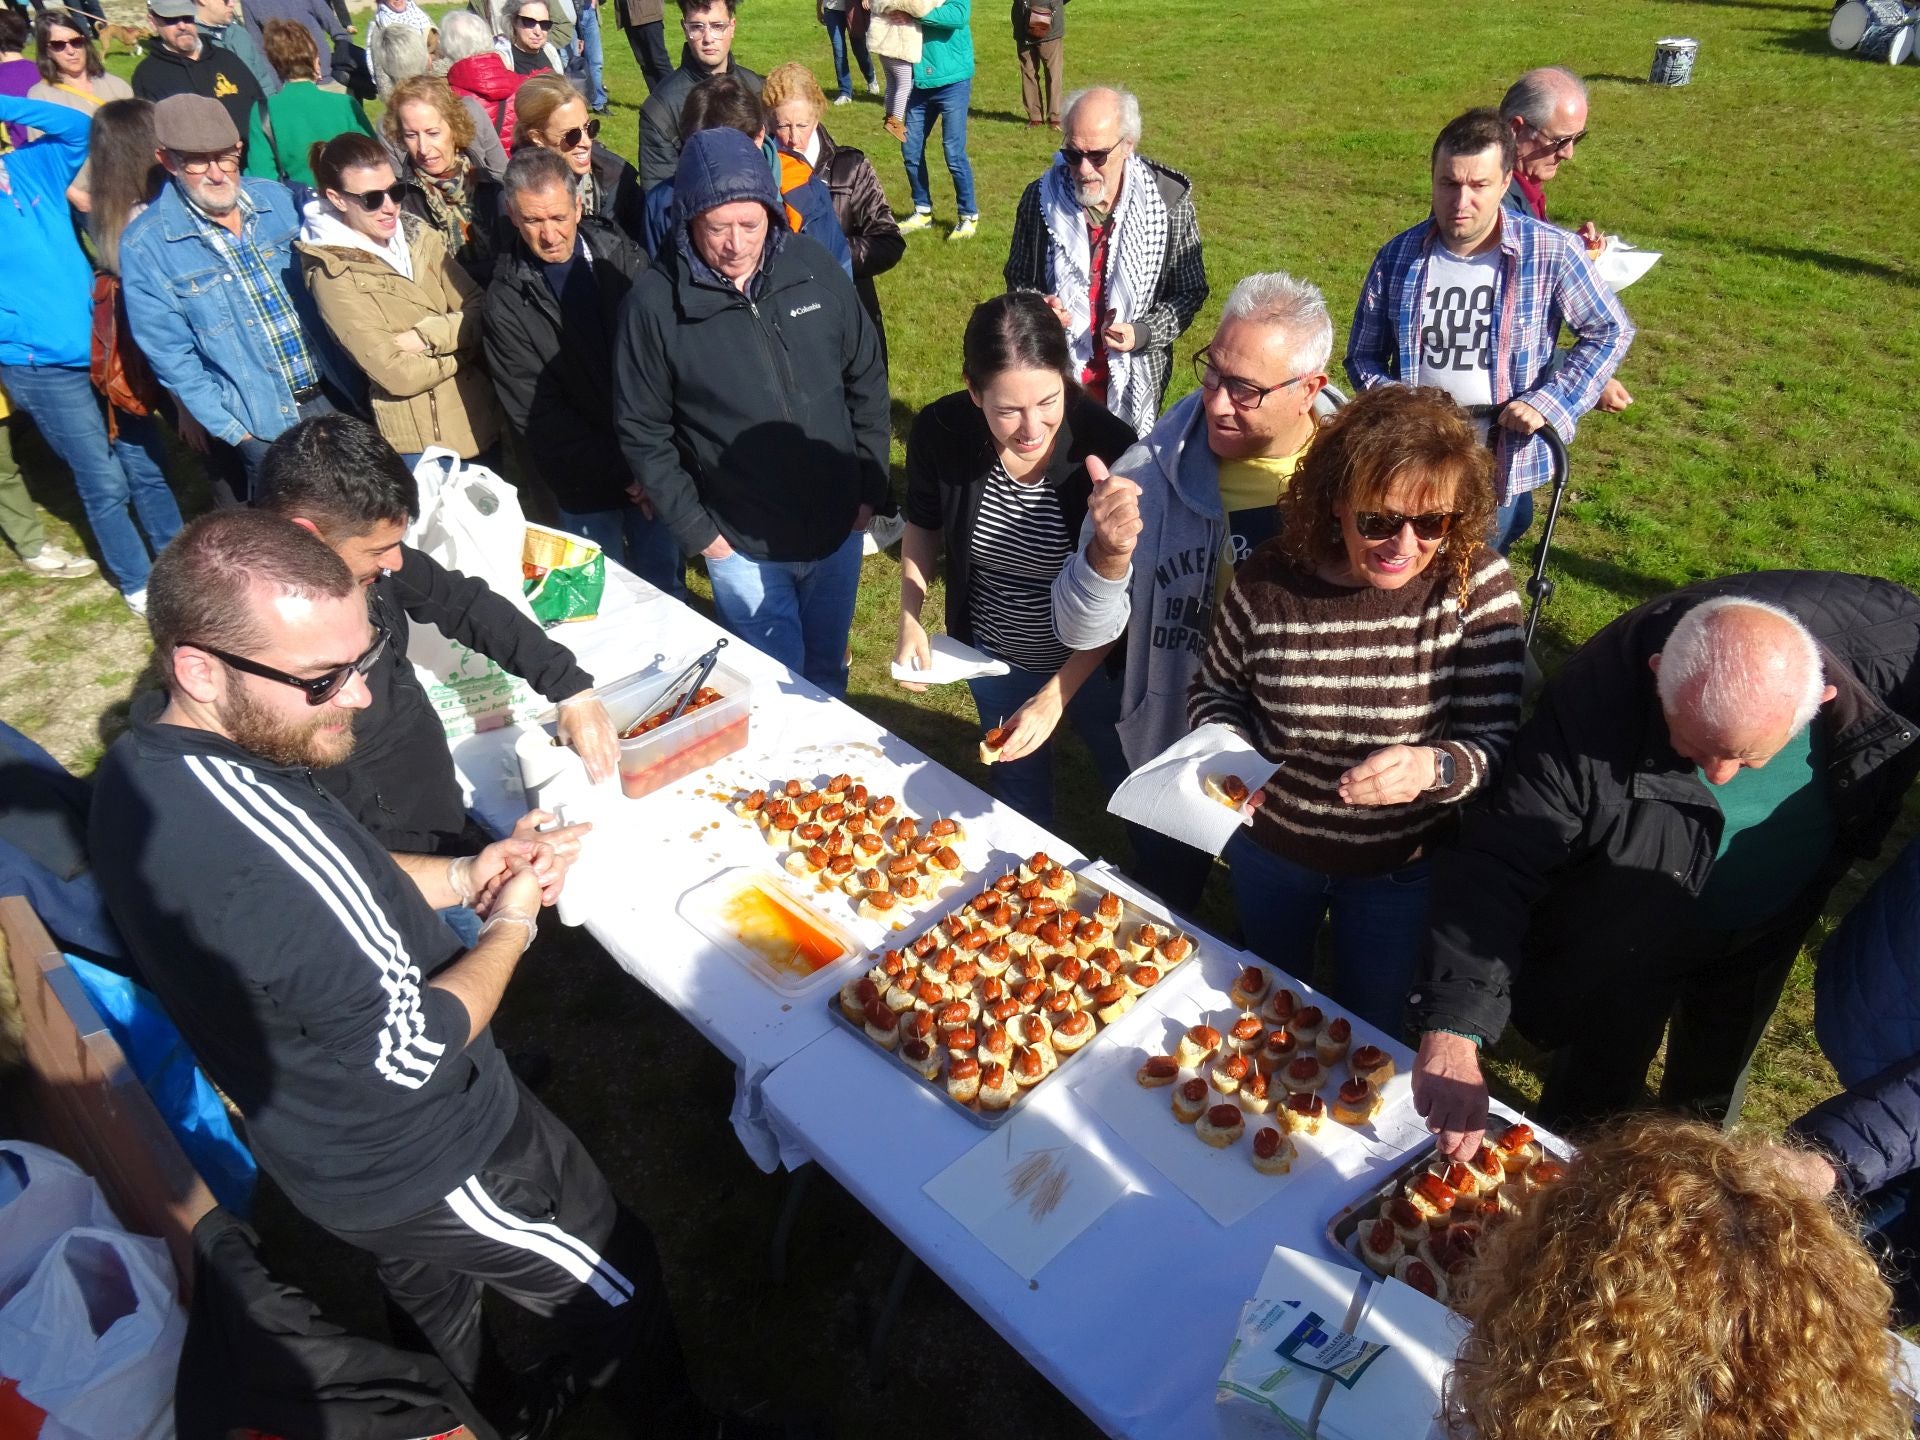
895,292,1133,826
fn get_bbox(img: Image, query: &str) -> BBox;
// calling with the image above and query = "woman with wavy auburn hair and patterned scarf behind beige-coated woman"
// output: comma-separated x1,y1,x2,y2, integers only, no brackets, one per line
380,75,507,288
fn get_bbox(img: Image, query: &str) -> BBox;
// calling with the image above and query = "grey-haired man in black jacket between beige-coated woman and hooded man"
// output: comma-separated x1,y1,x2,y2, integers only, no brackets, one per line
486,146,685,595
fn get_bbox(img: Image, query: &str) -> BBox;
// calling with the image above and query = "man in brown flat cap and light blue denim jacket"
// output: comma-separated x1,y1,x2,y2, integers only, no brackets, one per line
121,91,355,505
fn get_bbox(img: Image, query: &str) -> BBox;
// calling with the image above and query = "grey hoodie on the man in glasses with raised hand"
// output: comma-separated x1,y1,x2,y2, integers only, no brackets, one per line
1054,390,1227,770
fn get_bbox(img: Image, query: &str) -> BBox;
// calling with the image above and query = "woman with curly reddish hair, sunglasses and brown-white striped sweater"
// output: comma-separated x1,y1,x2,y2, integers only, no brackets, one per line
1187,386,1524,1035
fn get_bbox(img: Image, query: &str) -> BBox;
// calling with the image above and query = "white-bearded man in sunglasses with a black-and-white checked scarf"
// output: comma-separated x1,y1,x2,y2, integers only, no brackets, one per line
1004,86,1208,436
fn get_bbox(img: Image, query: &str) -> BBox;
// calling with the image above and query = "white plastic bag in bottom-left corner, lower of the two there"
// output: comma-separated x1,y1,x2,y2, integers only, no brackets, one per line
0,1225,186,1440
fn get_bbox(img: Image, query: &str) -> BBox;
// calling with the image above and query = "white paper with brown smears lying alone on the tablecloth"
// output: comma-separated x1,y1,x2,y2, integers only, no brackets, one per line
922,1096,1127,1281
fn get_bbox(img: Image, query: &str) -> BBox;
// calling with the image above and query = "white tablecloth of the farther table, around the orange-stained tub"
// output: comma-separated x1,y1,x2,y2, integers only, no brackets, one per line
453,563,1079,1171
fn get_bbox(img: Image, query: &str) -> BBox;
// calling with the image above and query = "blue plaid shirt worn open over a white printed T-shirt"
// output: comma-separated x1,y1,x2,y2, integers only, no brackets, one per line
1346,209,1634,505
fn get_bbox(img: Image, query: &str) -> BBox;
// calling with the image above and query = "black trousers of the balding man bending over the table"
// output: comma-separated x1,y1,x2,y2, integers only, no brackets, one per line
1521,889,1826,1129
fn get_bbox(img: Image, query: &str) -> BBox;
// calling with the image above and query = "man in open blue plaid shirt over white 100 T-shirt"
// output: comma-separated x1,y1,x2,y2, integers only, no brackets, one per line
1346,109,1634,555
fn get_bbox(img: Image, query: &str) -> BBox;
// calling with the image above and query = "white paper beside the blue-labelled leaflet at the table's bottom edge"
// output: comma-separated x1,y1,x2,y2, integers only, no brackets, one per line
1319,1279,1467,1440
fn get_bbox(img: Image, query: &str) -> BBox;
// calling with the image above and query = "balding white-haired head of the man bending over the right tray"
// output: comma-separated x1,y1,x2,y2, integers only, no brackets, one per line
1655,595,1826,737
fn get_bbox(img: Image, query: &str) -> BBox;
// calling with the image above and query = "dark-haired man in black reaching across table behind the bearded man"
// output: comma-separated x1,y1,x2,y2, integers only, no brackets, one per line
253,410,620,854
